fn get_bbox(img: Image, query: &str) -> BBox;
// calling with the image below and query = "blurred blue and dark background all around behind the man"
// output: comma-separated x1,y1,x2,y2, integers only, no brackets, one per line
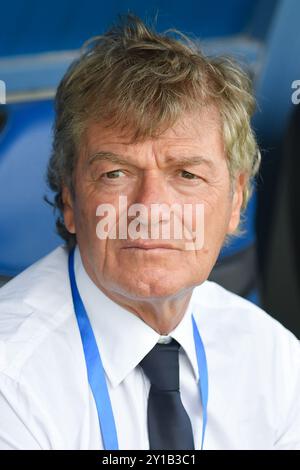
0,0,300,338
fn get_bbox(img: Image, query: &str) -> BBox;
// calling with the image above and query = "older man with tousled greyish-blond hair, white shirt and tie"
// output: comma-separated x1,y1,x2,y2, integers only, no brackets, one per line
0,13,300,450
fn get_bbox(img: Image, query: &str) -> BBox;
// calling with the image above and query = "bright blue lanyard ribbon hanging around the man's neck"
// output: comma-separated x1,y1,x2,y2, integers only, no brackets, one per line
69,248,208,450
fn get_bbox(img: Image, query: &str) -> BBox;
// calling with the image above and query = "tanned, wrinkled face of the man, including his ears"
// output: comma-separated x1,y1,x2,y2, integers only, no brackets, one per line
63,106,244,299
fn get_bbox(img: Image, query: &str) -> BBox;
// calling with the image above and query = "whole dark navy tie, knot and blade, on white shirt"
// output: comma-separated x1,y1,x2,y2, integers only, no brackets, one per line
140,339,195,450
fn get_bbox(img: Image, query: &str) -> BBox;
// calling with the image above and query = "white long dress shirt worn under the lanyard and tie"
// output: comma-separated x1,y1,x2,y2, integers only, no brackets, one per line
0,247,300,449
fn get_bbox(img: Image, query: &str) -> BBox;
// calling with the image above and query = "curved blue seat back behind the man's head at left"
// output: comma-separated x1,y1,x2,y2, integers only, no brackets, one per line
0,100,61,276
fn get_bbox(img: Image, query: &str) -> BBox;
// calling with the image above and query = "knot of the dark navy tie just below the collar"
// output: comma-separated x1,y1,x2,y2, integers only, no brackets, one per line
140,339,180,391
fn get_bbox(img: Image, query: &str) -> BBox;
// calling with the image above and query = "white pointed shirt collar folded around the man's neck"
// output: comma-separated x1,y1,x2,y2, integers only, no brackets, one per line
74,246,199,387
